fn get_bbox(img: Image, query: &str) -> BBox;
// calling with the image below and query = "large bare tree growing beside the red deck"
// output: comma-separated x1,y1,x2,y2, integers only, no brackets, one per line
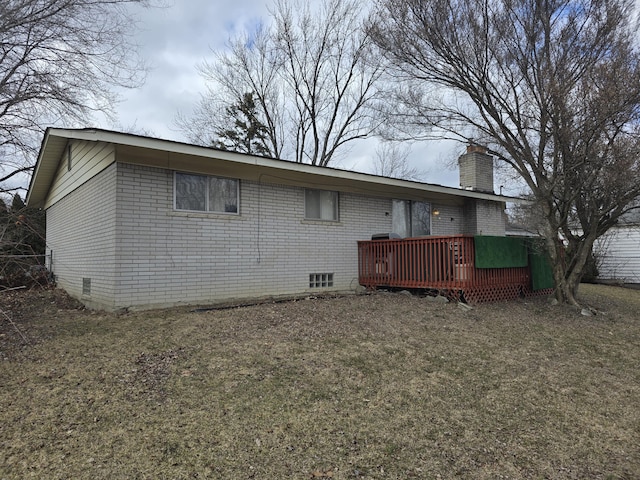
369,0,640,304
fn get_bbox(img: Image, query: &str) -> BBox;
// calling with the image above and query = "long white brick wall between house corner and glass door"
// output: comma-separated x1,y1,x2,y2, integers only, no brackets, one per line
116,164,391,307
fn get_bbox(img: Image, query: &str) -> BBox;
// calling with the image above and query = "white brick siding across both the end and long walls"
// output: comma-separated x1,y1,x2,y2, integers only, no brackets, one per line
47,158,504,310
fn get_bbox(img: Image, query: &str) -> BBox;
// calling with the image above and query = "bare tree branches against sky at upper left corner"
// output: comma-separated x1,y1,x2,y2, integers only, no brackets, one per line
0,0,160,191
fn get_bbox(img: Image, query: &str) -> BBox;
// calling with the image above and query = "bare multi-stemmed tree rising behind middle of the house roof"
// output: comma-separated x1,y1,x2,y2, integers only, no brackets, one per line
178,0,382,166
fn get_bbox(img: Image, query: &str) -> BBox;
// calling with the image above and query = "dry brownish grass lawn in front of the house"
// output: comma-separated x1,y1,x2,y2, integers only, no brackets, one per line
0,285,640,479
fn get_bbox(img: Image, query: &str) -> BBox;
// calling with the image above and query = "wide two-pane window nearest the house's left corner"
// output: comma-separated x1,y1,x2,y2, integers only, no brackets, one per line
174,172,239,213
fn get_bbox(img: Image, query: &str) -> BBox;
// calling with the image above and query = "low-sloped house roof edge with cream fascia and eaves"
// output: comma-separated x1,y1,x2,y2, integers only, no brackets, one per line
27,128,523,207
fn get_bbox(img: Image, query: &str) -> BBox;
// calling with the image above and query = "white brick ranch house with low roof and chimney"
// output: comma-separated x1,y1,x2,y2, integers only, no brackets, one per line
27,129,512,310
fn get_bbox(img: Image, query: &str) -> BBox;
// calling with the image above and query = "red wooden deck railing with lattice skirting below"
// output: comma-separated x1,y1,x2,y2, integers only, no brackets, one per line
358,235,532,303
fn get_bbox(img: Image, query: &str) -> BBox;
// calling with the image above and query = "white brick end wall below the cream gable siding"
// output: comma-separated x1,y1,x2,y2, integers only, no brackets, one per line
47,164,116,309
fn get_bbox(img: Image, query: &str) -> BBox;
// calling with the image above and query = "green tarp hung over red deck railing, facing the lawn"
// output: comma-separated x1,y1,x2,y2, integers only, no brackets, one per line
473,235,529,268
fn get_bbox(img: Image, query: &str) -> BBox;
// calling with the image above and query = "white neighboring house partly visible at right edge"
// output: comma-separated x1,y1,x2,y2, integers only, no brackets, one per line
594,210,640,284
